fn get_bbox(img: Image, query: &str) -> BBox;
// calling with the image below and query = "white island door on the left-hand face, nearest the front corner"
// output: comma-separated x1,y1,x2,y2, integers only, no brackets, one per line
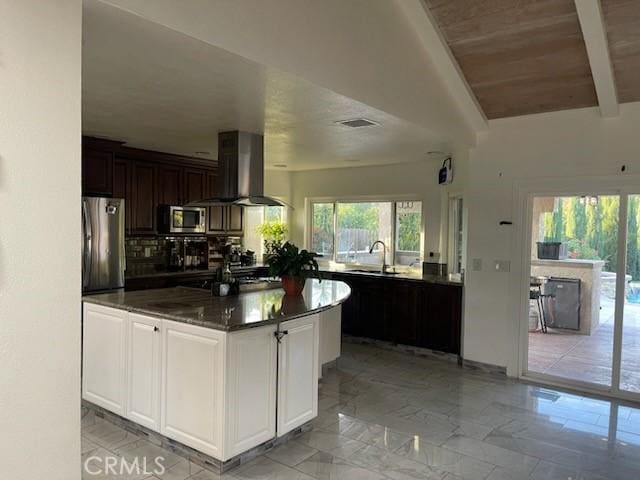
160,320,225,459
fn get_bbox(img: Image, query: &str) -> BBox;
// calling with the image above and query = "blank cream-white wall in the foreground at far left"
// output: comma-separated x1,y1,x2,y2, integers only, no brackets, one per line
0,0,81,480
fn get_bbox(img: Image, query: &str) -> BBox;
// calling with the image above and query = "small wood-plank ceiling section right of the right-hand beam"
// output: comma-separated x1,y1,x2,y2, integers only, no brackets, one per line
601,0,640,103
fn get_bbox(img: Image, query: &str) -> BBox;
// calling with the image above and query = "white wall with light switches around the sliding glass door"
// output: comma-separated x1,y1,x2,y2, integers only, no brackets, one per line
464,103,640,375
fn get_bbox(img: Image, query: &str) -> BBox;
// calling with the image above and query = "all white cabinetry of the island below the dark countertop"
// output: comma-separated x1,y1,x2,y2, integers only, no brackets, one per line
82,303,319,461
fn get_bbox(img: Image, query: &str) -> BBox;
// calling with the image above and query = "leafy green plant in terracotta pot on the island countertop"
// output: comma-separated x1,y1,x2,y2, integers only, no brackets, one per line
266,242,320,296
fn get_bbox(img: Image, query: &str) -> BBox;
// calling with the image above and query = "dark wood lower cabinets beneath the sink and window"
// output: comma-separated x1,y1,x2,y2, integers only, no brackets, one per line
328,274,462,354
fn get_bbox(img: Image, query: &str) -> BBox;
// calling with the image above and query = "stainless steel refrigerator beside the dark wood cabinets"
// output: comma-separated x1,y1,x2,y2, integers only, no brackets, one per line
82,197,125,293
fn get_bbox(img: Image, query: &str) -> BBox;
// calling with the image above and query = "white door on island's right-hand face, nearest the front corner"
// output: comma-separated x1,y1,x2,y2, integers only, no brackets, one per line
224,325,277,460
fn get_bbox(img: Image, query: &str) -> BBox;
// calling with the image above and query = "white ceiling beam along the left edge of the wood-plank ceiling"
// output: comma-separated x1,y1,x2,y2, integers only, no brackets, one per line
397,0,489,134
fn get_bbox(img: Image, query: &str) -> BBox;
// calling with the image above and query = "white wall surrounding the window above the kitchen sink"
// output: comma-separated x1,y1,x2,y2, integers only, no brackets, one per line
278,150,467,260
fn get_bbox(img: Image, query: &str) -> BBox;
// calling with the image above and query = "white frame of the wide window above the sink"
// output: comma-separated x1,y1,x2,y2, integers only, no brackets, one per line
304,194,426,268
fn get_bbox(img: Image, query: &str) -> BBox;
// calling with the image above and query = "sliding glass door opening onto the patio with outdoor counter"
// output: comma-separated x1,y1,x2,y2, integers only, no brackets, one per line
522,192,640,400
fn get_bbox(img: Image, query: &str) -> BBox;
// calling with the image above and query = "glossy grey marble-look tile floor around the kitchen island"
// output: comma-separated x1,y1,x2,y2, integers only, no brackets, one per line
82,344,640,480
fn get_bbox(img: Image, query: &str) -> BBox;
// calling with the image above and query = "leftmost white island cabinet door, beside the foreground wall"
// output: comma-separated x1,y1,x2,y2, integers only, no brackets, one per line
82,303,128,416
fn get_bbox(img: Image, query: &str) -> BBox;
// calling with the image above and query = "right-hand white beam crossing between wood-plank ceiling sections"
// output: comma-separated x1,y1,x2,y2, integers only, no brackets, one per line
575,0,620,117
